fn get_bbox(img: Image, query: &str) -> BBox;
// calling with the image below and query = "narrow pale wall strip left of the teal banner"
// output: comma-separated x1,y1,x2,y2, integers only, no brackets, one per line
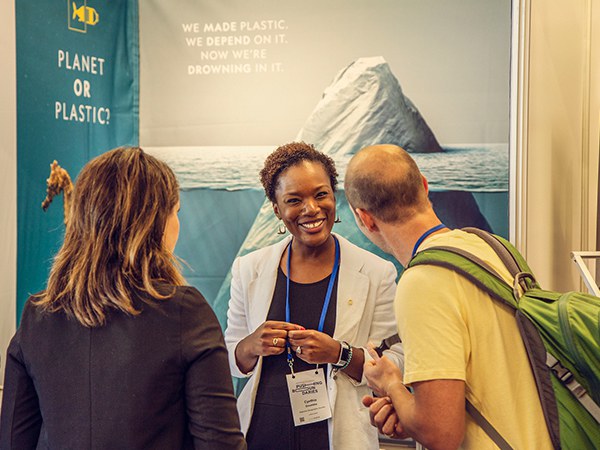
0,1,17,385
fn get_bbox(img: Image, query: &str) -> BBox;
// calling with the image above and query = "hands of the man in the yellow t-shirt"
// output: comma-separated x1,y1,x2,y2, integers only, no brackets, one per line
362,345,408,439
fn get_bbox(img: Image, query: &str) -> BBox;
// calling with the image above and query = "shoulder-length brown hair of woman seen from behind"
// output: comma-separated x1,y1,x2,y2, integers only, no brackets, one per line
36,147,184,327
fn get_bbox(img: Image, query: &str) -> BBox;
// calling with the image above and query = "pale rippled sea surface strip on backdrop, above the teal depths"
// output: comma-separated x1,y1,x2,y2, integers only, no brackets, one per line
144,143,508,192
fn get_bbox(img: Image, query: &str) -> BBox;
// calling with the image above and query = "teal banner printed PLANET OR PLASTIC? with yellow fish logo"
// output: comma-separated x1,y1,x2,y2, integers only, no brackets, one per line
15,0,139,318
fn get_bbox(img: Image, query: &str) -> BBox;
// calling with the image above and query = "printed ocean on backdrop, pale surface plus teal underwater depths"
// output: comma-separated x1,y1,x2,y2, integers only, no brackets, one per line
144,144,508,320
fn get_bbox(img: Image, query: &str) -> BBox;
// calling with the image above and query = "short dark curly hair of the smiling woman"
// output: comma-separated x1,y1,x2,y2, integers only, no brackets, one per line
260,142,338,203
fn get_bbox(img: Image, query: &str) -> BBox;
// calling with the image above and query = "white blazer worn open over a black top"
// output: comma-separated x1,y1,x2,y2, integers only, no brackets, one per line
225,235,403,450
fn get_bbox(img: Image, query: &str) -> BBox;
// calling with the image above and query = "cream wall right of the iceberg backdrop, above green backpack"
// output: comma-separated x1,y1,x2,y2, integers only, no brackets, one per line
513,0,600,290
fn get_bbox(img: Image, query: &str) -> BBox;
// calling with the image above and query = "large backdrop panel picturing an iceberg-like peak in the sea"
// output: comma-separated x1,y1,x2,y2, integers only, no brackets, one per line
140,0,511,323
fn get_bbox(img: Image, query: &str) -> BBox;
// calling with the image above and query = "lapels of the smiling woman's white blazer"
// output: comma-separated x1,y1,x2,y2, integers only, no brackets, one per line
248,234,370,343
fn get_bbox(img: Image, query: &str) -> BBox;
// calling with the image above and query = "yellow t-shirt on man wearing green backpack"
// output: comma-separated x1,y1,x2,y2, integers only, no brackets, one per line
395,230,552,450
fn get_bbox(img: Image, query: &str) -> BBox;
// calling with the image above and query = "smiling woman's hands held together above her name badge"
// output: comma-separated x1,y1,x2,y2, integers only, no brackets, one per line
248,320,340,364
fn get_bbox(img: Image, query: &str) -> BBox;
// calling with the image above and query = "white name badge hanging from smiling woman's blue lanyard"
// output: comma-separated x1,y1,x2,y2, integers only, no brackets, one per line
286,368,331,426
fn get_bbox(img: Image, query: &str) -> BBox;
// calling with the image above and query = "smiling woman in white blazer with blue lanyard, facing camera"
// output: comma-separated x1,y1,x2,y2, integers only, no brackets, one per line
225,143,402,450
